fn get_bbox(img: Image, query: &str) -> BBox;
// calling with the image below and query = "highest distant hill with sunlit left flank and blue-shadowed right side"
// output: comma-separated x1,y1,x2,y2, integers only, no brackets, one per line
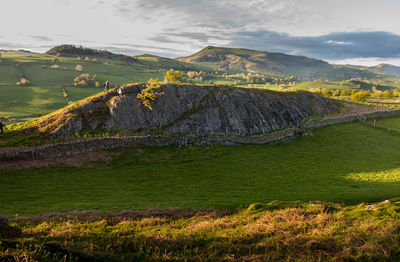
176,46,374,80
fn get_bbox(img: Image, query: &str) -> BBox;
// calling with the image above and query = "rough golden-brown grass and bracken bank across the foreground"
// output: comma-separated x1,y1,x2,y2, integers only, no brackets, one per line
0,199,400,261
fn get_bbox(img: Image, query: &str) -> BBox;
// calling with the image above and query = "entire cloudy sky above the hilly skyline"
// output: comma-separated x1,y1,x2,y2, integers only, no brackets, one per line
0,0,400,66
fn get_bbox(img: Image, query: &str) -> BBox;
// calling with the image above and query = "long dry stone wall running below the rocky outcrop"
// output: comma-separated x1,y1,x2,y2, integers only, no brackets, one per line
0,107,400,161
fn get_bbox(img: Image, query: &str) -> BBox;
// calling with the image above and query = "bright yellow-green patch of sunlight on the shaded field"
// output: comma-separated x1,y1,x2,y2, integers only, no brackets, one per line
345,168,400,183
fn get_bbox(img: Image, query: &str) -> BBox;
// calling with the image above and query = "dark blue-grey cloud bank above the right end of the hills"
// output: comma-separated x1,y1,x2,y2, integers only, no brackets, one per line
229,30,400,60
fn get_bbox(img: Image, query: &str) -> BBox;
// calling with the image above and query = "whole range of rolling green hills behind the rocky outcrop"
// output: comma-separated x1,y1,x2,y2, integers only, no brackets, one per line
0,45,400,123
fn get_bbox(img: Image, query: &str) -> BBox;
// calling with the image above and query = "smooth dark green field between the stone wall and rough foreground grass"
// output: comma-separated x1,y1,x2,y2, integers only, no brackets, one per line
0,123,400,215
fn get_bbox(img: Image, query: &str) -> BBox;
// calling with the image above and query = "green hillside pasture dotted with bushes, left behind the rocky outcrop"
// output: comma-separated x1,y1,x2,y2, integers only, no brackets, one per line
0,52,200,120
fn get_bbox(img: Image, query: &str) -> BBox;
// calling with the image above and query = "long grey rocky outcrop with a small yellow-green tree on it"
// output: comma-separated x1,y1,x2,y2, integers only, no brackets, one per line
33,84,338,138
